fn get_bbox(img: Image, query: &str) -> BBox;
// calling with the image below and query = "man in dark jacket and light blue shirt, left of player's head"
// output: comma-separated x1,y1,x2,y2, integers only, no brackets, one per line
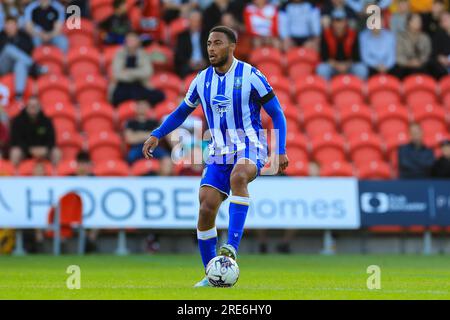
175,10,208,78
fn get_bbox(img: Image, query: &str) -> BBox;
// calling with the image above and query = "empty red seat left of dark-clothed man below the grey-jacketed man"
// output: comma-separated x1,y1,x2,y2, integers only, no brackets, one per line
88,131,122,162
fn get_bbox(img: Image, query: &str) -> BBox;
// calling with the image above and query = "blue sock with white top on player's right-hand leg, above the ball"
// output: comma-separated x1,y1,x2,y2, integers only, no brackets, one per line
227,196,250,251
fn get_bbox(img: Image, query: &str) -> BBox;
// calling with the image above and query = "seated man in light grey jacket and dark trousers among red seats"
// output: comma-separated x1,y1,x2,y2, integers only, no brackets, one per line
111,32,165,106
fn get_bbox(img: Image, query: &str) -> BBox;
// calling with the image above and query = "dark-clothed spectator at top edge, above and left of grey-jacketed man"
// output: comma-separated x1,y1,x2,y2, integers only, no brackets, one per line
99,0,131,44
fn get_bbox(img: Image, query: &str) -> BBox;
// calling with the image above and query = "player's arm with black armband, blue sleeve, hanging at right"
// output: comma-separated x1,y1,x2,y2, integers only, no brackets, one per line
250,68,289,172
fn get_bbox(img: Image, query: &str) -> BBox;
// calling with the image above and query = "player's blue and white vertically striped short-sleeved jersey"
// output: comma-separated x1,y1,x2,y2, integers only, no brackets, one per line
185,59,273,155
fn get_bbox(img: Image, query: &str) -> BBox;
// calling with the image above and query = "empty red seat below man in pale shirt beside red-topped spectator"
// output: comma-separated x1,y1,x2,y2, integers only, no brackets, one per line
367,74,401,107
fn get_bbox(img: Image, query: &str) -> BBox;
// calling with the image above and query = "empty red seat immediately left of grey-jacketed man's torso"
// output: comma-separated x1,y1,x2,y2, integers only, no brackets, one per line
67,46,102,79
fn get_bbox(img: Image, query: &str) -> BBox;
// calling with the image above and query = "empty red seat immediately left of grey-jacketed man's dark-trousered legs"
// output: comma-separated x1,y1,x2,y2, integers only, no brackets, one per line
75,74,108,105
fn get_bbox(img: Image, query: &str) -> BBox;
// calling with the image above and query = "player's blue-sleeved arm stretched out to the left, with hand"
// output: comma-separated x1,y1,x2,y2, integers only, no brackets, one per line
142,76,199,159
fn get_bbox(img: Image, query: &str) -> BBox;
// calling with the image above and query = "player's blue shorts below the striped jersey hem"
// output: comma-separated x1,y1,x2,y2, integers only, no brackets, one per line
200,149,266,197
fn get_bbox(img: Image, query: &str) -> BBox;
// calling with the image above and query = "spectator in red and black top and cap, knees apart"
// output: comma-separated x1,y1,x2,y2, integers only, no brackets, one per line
317,9,368,80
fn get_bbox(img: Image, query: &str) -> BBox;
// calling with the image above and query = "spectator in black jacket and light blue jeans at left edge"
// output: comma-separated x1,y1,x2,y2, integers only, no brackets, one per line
0,17,33,100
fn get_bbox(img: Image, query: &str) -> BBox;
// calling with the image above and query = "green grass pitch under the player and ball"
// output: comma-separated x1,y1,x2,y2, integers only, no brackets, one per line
0,255,450,300
